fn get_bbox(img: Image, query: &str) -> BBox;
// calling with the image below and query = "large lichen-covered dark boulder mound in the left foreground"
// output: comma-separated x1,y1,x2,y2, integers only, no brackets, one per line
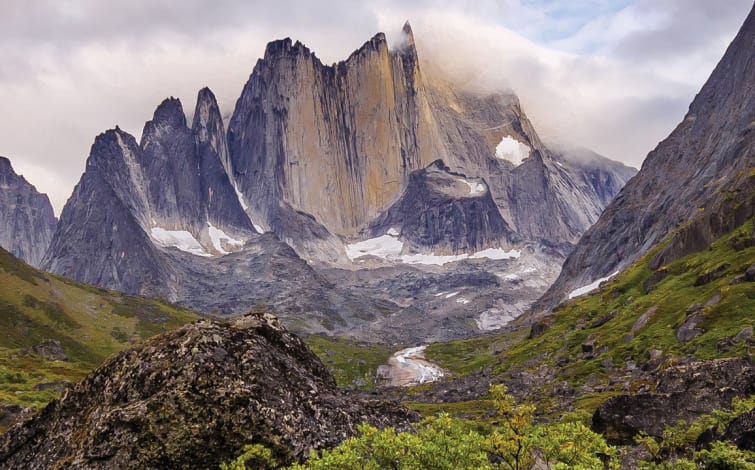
0,313,415,469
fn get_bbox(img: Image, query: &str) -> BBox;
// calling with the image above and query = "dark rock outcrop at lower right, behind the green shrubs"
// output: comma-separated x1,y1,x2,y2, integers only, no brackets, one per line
592,359,755,444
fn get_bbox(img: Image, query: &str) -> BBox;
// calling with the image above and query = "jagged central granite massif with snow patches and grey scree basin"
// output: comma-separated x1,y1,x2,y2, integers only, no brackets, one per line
0,23,635,340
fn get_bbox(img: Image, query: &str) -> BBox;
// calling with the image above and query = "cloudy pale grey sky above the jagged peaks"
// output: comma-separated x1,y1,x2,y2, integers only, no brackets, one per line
0,0,752,213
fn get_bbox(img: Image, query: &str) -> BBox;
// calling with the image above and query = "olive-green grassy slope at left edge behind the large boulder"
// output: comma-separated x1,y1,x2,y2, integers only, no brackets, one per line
0,248,196,408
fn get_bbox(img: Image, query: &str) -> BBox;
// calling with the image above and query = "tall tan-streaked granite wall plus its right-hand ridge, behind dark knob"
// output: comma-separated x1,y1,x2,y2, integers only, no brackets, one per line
228,24,633,252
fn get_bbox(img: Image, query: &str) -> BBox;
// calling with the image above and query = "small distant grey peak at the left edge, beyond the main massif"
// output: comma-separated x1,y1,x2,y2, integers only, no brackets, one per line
0,157,57,266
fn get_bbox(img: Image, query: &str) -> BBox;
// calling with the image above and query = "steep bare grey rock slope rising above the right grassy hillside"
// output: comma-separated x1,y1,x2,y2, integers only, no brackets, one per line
540,10,755,308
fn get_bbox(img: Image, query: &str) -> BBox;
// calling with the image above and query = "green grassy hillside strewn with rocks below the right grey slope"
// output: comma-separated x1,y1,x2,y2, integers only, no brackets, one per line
426,220,755,412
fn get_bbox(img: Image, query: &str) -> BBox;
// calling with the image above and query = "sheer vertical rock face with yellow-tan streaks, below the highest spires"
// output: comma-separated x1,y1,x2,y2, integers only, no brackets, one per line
229,28,438,236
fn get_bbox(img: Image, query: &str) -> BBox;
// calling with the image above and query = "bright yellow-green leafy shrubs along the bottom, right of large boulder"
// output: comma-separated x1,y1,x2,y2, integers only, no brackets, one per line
221,385,617,470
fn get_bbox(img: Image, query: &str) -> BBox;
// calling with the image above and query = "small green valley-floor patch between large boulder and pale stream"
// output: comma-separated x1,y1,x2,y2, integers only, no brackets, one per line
304,335,401,390
